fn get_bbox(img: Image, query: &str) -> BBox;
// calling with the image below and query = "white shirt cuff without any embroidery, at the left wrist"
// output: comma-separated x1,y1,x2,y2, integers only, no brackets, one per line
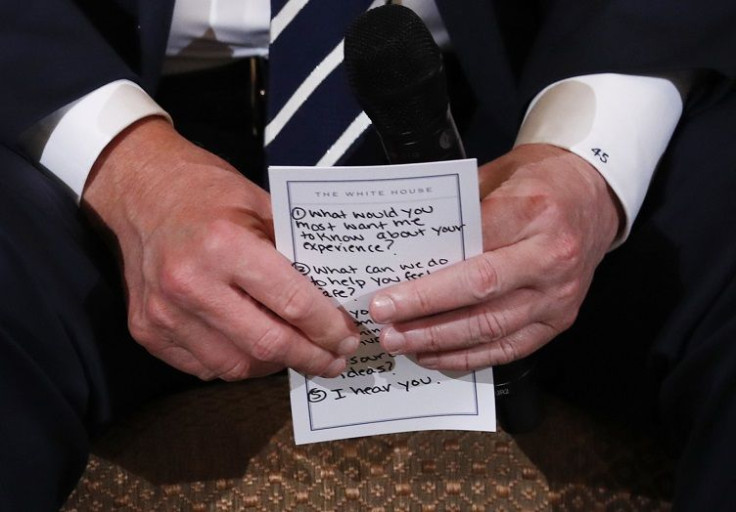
38,80,171,201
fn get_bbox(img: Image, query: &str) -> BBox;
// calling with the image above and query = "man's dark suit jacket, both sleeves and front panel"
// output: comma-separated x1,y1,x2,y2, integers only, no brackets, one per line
0,0,736,161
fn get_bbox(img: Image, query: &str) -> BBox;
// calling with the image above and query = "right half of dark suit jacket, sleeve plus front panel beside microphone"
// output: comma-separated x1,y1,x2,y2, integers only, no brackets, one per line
437,0,736,162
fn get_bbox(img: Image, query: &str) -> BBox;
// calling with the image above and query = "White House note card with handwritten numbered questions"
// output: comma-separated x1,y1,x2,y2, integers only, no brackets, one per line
270,160,496,444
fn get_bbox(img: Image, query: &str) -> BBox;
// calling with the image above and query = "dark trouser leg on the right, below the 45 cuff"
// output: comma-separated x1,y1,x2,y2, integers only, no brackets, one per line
542,86,736,511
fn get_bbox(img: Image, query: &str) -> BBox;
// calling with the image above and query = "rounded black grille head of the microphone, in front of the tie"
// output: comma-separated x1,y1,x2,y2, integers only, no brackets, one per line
344,5,448,133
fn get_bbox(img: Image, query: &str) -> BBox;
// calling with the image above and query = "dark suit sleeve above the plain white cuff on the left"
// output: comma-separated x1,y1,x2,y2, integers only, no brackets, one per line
0,0,160,148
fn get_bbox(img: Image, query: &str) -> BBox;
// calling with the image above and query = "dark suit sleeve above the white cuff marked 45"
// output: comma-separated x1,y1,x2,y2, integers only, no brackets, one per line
522,0,736,99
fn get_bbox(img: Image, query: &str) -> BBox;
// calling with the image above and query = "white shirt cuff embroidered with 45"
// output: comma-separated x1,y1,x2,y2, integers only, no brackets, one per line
515,73,683,246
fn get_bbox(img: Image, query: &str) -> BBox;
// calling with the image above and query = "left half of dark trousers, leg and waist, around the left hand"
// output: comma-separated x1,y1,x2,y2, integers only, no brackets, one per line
0,61,263,512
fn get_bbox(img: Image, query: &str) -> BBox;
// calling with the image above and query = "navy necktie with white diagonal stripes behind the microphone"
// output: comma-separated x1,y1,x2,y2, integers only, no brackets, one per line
265,0,376,165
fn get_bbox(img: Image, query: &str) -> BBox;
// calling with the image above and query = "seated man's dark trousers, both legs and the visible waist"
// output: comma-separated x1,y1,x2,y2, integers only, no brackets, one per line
0,63,736,512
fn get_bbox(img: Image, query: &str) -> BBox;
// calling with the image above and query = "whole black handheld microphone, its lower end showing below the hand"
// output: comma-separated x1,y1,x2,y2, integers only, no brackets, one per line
343,5,541,432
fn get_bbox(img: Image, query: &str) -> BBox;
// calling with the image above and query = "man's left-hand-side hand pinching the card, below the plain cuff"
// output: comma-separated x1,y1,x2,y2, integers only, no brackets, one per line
83,118,359,380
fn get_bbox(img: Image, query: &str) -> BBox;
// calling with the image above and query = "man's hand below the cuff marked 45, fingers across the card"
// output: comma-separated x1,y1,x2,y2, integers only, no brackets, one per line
370,144,620,370
